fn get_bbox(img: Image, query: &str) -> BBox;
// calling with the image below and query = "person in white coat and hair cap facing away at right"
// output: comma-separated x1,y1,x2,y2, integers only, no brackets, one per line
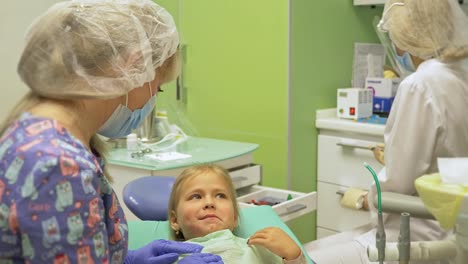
309,0,468,264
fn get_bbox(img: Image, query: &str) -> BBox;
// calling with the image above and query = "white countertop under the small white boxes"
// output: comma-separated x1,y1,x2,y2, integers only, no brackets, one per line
315,108,385,136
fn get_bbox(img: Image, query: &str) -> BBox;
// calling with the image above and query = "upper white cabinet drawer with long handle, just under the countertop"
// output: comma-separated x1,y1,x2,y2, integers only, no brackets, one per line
317,135,383,189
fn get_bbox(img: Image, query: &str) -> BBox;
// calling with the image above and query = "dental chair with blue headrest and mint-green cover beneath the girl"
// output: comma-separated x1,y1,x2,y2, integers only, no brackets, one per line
123,176,314,264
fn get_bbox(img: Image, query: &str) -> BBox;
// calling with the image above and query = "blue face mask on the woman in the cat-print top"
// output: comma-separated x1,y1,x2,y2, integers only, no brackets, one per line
98,87,156,138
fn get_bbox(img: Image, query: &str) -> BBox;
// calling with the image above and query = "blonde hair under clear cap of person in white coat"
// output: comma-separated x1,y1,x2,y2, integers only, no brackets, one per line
386,0,468,61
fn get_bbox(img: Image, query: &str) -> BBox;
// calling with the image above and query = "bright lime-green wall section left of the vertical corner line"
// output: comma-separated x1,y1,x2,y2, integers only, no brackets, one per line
158,0,288,191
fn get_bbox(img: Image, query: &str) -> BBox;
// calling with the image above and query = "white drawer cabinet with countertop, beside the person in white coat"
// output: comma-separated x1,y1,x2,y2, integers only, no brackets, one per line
316,109,384,239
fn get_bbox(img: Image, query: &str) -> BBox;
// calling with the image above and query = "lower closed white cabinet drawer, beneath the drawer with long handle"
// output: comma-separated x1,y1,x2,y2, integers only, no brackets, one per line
317,182,370,232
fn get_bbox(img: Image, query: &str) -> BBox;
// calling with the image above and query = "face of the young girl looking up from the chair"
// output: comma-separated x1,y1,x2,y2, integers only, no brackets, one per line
170,172,237,240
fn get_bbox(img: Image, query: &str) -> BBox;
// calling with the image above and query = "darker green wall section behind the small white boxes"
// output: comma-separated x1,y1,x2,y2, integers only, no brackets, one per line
289,0,382,242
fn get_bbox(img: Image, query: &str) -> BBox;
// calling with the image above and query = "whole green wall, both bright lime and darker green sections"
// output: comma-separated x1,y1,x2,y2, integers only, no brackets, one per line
157,0,382,242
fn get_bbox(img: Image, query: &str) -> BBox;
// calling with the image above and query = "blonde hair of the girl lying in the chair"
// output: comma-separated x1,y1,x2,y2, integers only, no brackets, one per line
167,164,239,241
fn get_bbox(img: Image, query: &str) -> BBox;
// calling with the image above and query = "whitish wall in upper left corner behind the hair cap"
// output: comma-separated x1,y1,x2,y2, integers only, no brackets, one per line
0,0,59,120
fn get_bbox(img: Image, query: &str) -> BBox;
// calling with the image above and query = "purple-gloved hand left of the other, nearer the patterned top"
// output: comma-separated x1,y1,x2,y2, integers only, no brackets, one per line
124,239,203,264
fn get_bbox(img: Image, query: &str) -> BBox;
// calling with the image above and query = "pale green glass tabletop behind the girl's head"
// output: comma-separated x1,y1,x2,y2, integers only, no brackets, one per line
107,137,258,170
